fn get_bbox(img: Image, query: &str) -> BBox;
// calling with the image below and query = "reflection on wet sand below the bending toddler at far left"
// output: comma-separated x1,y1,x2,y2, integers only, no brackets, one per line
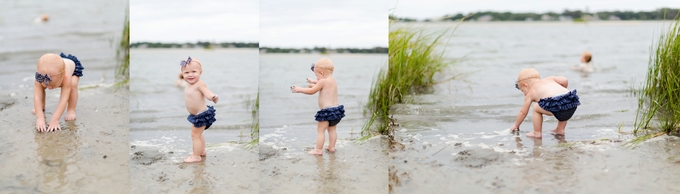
34,122,84,193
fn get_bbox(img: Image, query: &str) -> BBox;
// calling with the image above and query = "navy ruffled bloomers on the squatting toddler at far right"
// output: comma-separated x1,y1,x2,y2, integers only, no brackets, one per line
538,90,581,121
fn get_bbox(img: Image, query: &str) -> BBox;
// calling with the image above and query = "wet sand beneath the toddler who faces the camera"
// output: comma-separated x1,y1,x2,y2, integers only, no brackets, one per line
129,142,259,193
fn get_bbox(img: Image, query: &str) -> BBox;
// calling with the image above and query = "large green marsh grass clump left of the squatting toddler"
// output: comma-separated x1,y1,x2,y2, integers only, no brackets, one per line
361,23,456,136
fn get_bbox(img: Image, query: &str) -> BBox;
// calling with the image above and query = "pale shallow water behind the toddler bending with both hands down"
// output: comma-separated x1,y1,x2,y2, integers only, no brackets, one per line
0,0,128,90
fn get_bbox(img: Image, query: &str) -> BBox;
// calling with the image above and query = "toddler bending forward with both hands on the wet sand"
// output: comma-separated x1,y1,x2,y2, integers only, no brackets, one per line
33,53,84,132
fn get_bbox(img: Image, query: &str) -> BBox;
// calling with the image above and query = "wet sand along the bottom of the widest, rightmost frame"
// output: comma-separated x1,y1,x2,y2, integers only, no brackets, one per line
390,136,680,193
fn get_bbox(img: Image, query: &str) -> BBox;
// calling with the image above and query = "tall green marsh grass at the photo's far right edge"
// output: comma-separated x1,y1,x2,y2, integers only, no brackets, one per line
632,15,680,144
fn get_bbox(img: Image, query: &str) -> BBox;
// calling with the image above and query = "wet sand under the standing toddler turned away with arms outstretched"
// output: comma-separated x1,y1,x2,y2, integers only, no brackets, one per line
259,136,388,193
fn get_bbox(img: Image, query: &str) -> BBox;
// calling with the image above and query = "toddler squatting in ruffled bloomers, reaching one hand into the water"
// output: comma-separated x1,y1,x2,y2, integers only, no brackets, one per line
510,68,581,138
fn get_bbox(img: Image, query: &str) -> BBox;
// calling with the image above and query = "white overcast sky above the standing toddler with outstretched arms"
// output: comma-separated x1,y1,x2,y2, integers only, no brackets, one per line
260,0,389,48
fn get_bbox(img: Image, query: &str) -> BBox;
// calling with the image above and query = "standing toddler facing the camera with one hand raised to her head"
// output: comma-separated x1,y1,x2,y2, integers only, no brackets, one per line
180,57,219,162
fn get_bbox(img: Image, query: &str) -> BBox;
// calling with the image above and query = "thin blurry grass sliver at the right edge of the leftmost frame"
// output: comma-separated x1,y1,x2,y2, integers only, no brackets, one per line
115,9,130,88
